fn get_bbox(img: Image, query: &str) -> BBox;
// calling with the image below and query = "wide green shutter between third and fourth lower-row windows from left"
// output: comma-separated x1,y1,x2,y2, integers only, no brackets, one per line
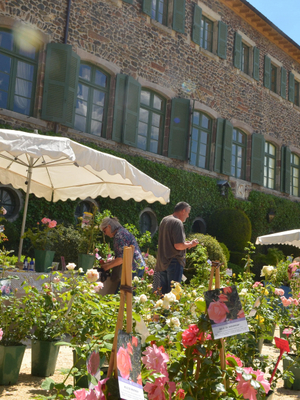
168,98,190,160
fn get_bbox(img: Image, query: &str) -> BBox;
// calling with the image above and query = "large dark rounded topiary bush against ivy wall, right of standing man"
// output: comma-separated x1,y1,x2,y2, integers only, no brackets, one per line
207,208,252,252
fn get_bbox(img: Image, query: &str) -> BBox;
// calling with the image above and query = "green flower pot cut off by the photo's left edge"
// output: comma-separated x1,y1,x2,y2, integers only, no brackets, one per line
0,344,26,385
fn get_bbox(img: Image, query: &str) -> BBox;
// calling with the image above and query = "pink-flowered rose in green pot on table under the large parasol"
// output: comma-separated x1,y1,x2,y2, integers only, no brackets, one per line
23,218,58,272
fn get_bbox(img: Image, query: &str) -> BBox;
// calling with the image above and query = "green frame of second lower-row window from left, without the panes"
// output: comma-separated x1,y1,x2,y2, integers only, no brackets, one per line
74,61,111,138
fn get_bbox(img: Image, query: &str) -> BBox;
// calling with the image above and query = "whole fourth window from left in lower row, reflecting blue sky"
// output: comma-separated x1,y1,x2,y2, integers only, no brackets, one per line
190,111,212,169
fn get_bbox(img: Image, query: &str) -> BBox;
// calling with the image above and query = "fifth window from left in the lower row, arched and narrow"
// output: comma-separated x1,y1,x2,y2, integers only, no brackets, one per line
231,129,247,179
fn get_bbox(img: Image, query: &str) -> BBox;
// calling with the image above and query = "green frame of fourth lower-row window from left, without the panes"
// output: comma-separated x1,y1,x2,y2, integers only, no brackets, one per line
188,109,214,170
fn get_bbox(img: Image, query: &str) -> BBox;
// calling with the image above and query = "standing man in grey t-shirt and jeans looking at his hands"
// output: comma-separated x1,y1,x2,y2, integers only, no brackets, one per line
156,201,198,294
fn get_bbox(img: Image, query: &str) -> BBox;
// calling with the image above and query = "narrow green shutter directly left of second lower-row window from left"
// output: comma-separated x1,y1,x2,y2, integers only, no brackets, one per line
65,52,80,127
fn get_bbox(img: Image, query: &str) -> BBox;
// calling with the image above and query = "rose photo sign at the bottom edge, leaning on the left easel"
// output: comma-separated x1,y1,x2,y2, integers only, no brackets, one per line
117,330,144,400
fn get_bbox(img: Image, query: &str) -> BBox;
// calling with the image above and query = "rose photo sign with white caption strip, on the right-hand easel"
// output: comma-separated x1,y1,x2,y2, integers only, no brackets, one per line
204,286,249,339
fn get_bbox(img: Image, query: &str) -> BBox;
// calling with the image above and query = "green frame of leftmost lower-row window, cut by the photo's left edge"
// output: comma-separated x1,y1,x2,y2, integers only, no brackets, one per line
0,27,39,116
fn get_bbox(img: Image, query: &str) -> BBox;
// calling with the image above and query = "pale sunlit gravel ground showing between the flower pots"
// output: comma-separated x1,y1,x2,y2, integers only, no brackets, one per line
0,336,300,400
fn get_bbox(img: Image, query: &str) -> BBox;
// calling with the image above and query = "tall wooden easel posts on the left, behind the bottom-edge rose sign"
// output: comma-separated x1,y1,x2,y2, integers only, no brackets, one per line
107,246,134,378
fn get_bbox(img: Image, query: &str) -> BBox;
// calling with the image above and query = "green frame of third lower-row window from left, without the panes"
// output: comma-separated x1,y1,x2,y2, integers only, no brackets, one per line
136,87,167,155
